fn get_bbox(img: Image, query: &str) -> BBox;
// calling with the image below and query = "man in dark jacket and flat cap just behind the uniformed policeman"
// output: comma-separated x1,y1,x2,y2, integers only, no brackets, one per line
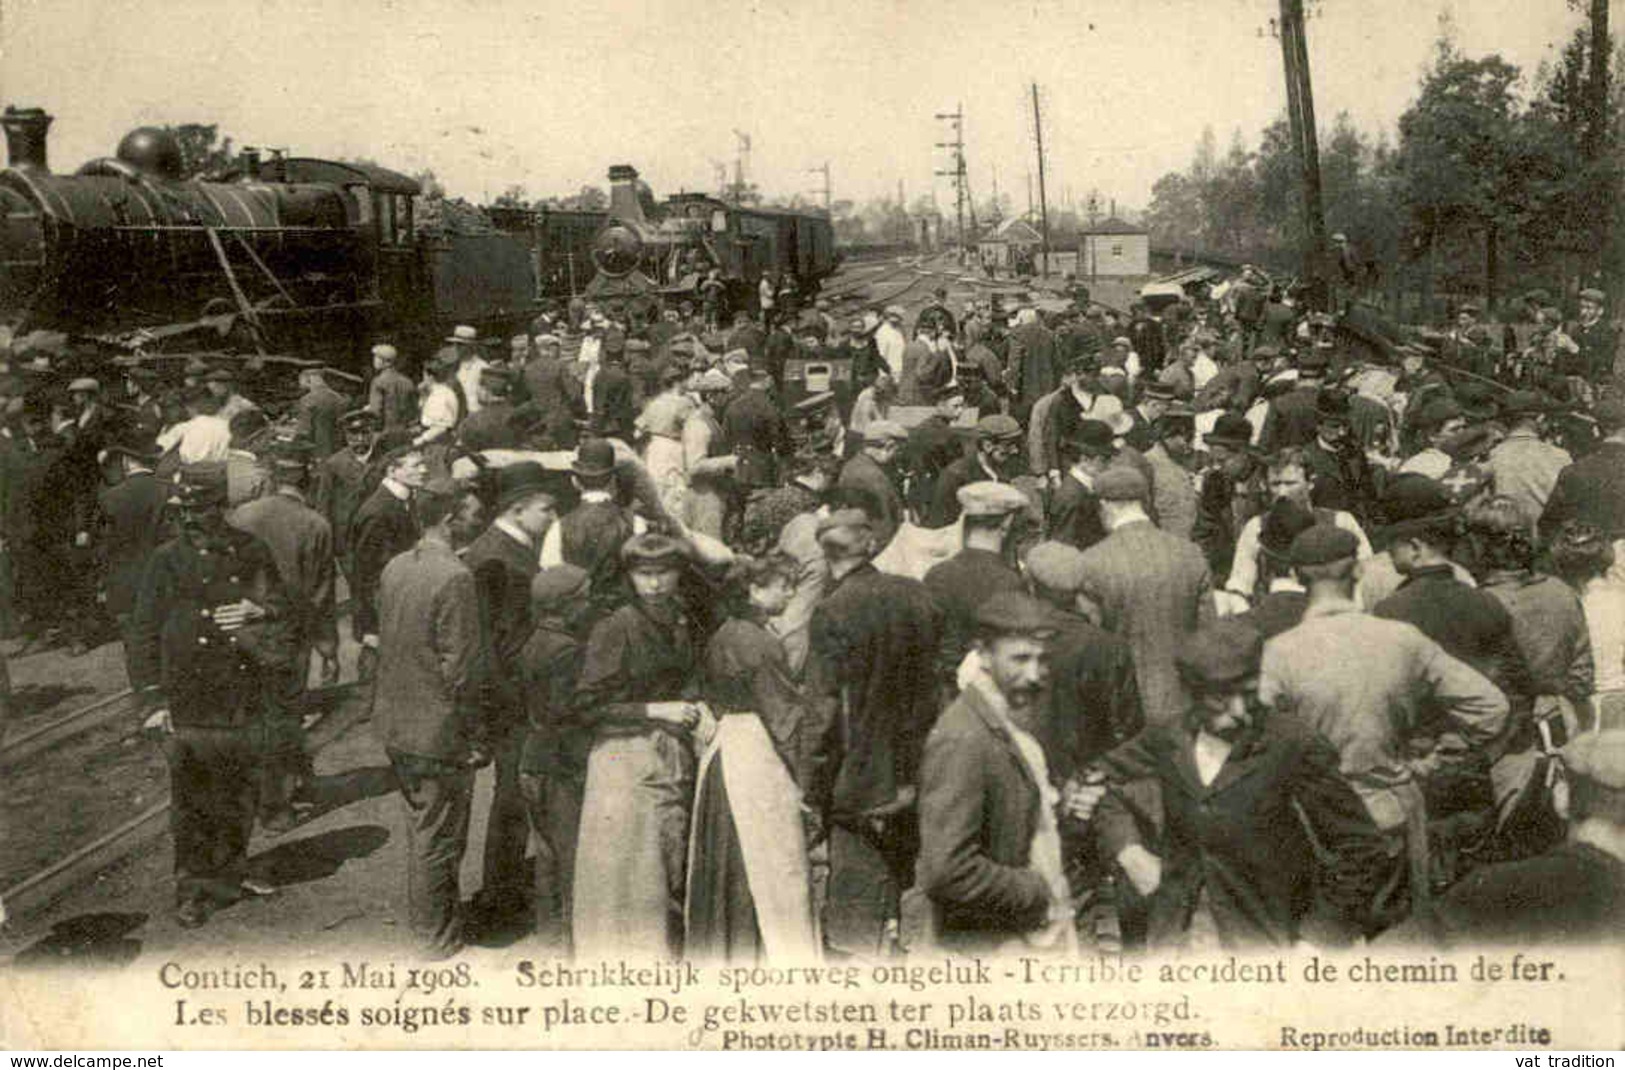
229,439,338,833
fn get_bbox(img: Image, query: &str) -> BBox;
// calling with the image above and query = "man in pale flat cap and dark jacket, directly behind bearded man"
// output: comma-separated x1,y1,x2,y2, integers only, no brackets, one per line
925,481,1027,696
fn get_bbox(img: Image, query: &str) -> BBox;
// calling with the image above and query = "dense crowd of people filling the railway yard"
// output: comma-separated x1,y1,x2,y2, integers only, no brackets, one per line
0,266,1625,959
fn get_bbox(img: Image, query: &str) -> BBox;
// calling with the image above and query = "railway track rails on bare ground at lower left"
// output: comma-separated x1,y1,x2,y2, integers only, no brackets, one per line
0,683,366,917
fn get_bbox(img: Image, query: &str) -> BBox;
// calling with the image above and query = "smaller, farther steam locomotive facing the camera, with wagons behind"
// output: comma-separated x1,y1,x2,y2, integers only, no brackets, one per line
492,164,840,309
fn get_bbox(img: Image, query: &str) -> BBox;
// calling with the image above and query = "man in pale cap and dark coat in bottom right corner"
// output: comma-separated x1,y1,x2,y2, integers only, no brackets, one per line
1383,729,1625,948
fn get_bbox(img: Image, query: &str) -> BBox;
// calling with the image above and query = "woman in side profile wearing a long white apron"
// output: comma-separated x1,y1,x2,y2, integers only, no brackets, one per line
686,555,819,963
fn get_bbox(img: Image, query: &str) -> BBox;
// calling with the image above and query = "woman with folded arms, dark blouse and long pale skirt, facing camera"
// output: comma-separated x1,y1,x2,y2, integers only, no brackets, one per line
572,533,707,959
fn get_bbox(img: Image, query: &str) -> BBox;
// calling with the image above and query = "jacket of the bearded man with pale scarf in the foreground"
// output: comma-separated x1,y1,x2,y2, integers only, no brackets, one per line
918,688,1050,951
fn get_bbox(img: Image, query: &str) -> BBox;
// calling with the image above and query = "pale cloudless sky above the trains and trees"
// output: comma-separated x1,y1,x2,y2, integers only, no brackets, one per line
0,0,1599,213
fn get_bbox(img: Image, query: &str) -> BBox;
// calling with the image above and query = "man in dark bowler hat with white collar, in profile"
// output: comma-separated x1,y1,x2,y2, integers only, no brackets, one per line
462,458,570,927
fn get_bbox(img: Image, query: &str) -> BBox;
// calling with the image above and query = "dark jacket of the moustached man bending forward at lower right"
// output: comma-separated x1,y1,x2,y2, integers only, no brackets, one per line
1095,712,1386,946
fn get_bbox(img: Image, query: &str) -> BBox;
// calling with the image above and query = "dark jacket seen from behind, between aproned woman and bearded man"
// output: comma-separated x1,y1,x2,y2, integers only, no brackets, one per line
806,564,941,821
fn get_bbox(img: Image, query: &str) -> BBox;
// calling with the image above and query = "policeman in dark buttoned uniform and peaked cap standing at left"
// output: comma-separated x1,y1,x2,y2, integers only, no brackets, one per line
132,465,294,929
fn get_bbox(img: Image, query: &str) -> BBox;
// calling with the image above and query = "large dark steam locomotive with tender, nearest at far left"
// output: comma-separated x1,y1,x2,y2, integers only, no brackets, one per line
0,107,536,363
